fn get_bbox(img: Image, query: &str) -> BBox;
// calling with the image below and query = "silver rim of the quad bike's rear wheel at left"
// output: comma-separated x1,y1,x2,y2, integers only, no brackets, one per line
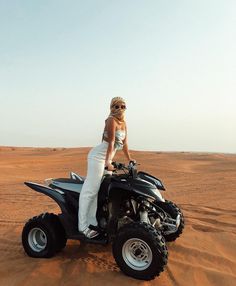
28,227,47,252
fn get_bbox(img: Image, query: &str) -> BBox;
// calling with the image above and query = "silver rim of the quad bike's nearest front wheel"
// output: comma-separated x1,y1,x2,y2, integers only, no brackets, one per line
122,238,152,271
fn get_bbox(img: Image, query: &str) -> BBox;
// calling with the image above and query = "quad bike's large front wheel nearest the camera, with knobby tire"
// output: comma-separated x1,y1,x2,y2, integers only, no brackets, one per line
112,222,168,280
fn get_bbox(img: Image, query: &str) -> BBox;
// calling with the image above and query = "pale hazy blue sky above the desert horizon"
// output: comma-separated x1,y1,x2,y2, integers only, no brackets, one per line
0,0,236,153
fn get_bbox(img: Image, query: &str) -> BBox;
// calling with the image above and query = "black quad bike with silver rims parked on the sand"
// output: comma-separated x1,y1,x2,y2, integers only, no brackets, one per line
22,162,184,280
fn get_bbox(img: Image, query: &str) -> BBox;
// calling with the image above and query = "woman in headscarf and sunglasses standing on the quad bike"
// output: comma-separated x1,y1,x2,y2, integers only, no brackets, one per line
78,97,134,238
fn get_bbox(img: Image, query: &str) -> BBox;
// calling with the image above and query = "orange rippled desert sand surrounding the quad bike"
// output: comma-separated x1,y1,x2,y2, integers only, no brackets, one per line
0,147,236,286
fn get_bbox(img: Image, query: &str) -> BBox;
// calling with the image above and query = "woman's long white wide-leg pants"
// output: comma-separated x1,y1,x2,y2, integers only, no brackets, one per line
78,141,115,231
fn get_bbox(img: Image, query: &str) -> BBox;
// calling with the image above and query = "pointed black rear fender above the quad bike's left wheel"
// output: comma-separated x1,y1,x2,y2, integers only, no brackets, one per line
24,182,67,213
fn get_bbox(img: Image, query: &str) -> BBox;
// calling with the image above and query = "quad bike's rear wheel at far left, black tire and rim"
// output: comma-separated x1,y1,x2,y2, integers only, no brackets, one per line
22,213,66,258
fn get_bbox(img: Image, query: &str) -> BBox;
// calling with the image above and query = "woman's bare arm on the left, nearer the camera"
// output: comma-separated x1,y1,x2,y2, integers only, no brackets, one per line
105,118,116,171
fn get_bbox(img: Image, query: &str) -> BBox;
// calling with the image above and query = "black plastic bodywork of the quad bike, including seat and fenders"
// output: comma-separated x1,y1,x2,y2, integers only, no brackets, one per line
25,168,164,239
